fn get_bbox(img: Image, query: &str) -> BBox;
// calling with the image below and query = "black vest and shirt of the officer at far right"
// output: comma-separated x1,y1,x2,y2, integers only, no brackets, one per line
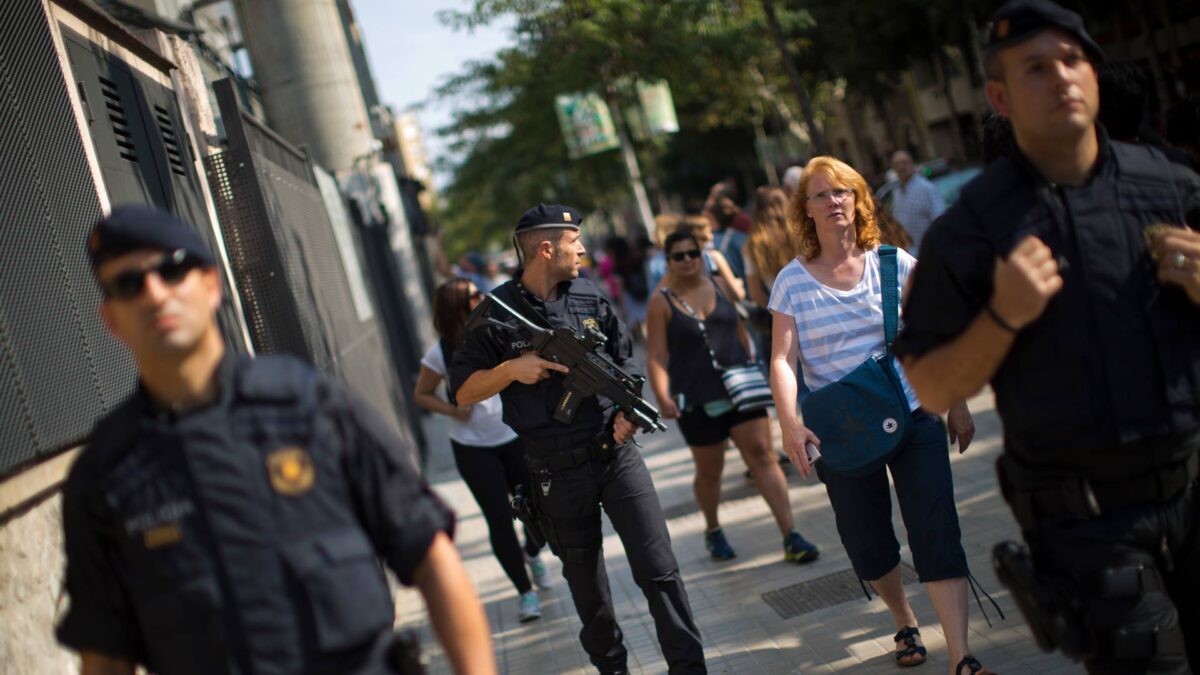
962,143,1200,470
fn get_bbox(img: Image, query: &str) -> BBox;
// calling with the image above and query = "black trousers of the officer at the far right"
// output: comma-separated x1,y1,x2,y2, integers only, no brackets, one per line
1002,449,1200,675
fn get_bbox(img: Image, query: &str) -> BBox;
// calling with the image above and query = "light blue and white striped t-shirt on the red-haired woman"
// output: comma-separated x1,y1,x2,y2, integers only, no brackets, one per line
767,249,920,410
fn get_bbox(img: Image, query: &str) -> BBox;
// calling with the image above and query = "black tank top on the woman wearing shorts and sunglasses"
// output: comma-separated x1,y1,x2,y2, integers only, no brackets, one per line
662,282,749,407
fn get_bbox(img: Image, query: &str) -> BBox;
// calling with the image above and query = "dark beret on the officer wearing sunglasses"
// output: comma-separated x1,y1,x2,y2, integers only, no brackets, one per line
88,204,216,269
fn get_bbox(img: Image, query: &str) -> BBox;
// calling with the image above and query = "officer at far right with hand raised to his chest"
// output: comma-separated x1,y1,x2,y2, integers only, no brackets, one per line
896,0,1200,673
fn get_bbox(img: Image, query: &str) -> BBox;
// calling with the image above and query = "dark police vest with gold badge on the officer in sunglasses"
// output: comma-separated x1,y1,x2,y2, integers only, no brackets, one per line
88,357,392,675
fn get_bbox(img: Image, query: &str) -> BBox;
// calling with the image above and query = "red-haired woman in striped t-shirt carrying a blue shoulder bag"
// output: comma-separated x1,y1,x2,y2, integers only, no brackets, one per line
770,156,980,675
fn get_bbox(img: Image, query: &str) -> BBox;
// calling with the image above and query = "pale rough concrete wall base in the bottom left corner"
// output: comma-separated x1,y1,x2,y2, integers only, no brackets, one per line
0,487,79,675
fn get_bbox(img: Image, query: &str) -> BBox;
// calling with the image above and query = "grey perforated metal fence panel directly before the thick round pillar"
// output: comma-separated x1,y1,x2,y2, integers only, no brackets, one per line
205,80,408,432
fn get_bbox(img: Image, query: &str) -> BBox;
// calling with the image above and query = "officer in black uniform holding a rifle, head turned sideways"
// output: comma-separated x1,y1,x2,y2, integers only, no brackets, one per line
450,204,706,673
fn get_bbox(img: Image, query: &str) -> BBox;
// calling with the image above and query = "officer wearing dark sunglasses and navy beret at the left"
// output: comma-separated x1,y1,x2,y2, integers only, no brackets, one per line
58,205,496,675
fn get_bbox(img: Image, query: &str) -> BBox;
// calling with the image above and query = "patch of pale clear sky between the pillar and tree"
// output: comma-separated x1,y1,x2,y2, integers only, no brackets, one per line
350,0,514,183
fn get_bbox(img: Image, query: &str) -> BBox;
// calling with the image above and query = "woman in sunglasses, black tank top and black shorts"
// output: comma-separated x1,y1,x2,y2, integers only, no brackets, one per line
647,229,817,562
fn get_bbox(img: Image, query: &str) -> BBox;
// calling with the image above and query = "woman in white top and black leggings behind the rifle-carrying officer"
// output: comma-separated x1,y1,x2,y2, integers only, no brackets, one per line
413,279,552,622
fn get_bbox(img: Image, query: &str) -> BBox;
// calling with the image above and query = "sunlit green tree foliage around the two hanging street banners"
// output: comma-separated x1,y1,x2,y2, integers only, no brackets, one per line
437,0,816,253
